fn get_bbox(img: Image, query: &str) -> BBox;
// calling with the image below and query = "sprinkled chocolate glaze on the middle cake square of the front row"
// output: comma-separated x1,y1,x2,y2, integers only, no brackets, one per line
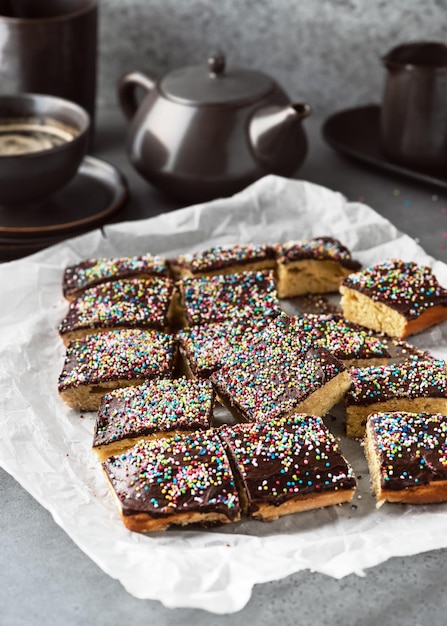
219,415,356,514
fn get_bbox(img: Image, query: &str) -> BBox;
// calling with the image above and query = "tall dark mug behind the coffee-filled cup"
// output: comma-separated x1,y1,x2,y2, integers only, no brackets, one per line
0,0,98,130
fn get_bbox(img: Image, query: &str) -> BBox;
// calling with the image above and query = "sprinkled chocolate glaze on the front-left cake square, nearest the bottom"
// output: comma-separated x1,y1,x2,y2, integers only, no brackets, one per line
103,431,240,521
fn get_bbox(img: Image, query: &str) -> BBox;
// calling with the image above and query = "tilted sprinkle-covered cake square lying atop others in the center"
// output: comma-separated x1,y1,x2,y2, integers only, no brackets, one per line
210,316,350,422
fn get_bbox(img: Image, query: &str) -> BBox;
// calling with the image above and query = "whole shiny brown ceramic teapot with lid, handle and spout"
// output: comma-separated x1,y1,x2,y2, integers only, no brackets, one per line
118,54,311,202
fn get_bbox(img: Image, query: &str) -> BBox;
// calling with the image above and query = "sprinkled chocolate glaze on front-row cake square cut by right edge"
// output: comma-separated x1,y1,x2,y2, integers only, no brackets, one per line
368,412,447,491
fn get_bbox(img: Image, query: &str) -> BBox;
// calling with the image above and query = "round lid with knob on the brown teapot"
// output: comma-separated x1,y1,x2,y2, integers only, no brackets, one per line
159,53,274,105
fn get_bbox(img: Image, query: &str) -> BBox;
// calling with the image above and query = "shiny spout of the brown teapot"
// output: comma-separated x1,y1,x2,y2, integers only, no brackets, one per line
249,102,312,176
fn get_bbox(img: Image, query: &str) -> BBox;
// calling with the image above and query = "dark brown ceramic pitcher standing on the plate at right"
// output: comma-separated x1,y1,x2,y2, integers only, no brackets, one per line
380,42,447,175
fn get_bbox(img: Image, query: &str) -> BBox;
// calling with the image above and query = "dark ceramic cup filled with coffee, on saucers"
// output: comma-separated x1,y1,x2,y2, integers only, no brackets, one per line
0,94,89,210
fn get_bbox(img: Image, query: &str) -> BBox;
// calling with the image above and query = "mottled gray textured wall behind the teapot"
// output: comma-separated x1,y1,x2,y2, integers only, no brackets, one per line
98,0,447,116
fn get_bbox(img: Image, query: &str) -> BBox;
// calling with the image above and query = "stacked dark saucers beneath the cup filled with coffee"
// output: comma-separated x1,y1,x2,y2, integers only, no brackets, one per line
0,156,128,260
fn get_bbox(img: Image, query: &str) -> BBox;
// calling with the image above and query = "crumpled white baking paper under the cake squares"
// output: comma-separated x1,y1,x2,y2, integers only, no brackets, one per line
0,176,447,613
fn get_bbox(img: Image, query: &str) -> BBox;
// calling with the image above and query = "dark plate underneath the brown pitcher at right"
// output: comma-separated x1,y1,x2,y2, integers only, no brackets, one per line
322,105,447,189
